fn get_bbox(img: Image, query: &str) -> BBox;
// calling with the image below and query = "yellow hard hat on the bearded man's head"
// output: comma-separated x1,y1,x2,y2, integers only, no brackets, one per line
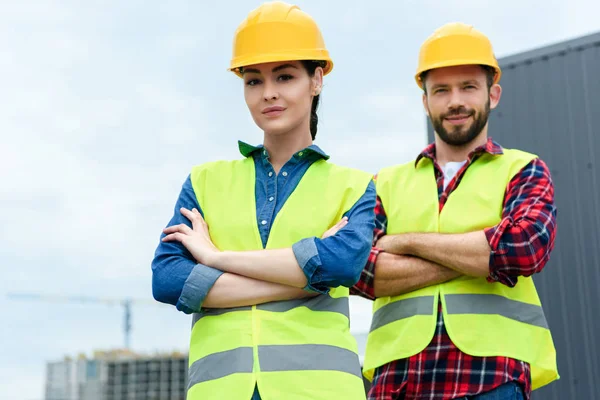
415,22,502,88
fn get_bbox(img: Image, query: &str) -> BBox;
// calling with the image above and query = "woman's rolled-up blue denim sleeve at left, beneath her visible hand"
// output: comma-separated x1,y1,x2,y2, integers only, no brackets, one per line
152,176,223,314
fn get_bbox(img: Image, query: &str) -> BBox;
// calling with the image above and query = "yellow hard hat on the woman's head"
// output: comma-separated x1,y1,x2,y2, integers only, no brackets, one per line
229,1,333,76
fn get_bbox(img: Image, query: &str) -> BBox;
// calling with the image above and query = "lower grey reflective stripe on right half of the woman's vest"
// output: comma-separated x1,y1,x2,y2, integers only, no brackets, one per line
258,344,362,378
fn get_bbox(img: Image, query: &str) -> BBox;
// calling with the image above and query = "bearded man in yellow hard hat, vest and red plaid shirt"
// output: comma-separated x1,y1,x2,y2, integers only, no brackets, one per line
352,23,558,400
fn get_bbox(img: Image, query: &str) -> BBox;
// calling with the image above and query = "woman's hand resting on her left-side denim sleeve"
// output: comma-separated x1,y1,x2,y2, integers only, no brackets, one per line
162,207,220,266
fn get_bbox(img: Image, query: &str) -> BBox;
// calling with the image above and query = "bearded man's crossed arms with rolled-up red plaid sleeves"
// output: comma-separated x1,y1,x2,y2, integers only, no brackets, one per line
351,159,556,299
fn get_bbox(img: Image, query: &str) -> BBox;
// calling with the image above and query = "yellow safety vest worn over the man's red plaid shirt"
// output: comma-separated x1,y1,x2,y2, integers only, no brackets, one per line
364,149,558,389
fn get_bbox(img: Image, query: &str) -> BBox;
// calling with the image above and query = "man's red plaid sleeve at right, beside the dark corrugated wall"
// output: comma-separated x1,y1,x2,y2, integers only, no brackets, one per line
485,158,556,287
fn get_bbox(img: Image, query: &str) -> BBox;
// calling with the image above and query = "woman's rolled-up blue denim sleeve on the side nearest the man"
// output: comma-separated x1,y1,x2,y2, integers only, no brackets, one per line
292,181,377,293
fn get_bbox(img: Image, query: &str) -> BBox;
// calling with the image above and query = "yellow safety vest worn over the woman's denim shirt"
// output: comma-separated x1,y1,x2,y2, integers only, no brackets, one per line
187,157,372,400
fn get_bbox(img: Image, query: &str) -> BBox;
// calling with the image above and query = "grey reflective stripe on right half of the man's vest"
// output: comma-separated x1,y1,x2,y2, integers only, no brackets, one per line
445,294,548,329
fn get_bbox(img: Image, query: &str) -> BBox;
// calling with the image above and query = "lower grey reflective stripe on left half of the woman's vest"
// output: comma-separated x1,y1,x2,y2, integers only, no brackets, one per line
188,347,254,389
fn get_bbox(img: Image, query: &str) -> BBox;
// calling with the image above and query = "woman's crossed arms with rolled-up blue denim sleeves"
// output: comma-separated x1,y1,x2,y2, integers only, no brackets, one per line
152,177,376,313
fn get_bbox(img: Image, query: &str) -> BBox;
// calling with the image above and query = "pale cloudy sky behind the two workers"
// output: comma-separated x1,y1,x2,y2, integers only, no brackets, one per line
0,0,600,400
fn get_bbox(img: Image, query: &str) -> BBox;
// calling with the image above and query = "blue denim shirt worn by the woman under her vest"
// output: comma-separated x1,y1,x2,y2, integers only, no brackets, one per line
152,142,376,314
